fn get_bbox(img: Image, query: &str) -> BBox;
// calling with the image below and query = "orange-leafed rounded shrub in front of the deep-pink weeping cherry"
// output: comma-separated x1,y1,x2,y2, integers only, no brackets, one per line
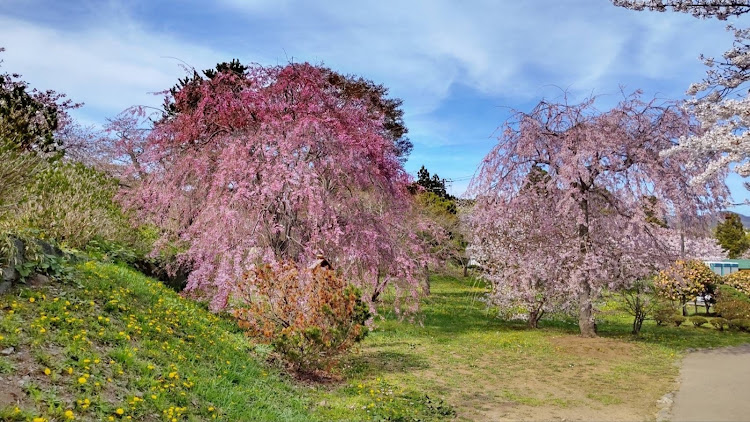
232,262,370,373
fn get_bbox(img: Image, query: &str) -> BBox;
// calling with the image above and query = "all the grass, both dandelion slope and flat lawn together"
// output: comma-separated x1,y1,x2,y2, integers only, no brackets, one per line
0,263,750,421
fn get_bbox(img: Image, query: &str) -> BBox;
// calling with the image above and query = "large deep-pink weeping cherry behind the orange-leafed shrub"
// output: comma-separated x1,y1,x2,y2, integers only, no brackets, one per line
129,63,429,309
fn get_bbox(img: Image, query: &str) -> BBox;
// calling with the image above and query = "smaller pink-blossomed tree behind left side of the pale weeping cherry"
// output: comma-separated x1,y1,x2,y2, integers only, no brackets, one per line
469,167,575,328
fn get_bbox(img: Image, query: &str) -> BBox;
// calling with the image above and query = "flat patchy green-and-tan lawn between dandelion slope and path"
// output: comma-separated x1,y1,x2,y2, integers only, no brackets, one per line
314,276,750,421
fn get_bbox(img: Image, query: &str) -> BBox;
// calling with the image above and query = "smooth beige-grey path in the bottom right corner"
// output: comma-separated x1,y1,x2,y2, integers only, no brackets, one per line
672,345,750,422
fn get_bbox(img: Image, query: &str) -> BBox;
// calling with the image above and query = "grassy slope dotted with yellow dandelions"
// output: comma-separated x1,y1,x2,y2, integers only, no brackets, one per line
0,263,310,421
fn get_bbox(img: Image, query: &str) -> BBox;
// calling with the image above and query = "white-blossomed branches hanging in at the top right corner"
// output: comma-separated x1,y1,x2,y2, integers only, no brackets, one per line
613,0,750,183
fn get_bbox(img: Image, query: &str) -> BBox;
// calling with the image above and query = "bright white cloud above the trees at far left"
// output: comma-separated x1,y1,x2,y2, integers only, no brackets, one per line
0,16,241,121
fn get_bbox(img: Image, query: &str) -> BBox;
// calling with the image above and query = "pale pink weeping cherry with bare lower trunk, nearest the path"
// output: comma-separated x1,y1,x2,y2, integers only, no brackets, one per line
470,92,727,336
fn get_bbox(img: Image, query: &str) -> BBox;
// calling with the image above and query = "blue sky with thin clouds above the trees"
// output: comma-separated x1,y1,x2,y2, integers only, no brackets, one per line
0,0,750,214
